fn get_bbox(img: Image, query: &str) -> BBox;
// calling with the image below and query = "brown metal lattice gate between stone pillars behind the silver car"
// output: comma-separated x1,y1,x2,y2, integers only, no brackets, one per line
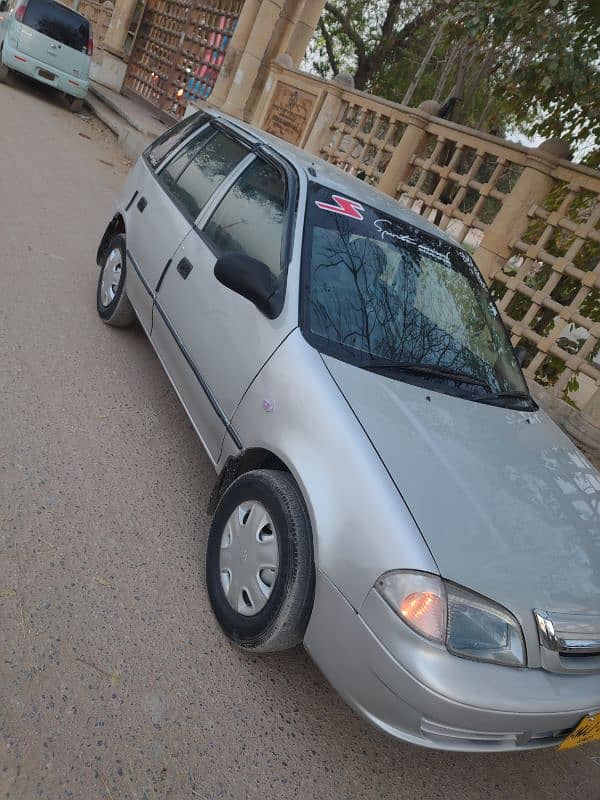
124,0,244,117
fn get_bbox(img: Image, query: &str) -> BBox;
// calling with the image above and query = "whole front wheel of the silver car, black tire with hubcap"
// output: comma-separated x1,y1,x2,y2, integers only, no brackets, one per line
206,469,314,653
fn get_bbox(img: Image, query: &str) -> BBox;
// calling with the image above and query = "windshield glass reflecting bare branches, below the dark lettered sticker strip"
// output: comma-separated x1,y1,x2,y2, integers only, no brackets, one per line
310,214,525,391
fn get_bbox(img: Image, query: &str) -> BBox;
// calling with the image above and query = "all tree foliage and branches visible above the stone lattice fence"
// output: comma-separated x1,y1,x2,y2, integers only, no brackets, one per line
309,0,600,155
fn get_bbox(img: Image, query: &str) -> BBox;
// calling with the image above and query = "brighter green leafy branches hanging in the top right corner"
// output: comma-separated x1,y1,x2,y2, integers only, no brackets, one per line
451,0,600,152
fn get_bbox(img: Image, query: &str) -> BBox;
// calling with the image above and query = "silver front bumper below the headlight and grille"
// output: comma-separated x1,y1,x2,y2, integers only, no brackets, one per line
305,572,600,751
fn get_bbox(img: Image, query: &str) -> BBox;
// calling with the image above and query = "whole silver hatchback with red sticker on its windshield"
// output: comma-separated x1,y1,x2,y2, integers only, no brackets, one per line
97,112,600,750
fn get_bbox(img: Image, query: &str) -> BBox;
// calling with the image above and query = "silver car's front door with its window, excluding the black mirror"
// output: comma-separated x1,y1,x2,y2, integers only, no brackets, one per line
153,155,297,461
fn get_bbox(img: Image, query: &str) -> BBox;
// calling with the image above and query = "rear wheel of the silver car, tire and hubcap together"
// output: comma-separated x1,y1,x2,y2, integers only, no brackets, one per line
96,233,136,328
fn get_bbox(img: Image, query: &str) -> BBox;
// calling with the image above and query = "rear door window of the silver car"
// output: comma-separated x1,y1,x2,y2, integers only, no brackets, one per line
158,131,249,220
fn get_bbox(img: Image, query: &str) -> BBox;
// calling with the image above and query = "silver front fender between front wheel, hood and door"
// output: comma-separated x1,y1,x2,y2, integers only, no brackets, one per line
219,329,437,609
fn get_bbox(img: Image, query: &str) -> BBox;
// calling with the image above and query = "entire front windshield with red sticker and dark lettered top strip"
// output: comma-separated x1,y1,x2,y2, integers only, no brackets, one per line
303,185,532,408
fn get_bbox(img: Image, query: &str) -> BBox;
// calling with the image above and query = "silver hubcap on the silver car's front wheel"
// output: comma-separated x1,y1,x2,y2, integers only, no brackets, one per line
219,500,279,617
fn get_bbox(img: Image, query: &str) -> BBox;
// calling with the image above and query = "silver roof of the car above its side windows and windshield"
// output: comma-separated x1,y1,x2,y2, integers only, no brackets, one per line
202,108,464,249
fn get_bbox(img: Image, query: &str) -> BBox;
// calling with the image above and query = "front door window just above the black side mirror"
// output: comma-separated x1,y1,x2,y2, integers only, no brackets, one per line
204,158,286,278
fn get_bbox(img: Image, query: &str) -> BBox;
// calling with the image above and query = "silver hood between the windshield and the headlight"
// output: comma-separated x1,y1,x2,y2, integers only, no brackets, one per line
324,356,600,640
